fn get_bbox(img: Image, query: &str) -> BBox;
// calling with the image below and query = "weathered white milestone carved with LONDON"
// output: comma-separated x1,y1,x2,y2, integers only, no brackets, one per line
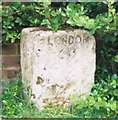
21,28,96,108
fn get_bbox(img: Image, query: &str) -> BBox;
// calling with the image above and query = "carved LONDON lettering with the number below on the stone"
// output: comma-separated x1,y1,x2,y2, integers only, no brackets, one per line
37,33,89,59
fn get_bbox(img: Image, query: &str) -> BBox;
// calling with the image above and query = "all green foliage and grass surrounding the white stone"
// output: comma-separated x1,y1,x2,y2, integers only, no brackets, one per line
1,2,118,118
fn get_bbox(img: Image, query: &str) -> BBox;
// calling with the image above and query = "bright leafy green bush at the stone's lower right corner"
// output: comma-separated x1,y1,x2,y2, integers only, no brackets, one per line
68,75,118,118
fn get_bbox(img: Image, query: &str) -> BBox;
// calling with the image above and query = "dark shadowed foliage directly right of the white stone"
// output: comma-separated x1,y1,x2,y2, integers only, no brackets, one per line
96,33,118,78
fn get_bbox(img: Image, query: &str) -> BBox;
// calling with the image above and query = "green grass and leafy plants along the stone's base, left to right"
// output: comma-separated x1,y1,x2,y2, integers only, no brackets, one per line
2,74,118,118
